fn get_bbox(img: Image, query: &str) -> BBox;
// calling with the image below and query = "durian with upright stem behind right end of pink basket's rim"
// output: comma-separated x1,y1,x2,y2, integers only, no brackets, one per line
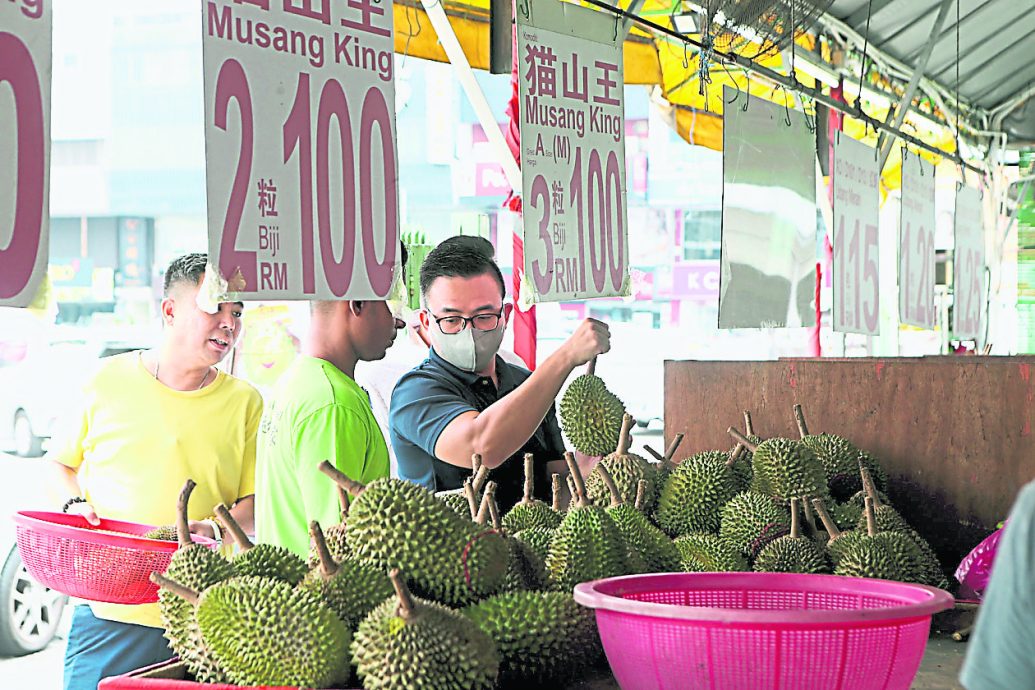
834,497,923,582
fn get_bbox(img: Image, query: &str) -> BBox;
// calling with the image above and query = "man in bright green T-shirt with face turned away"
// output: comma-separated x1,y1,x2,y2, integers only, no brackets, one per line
255,248,406,558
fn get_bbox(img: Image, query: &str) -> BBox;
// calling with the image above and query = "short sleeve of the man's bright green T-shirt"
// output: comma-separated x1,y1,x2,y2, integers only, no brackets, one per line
294,404,371,527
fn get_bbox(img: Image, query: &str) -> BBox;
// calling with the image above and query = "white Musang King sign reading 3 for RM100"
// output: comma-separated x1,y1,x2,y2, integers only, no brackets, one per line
516,0,630,303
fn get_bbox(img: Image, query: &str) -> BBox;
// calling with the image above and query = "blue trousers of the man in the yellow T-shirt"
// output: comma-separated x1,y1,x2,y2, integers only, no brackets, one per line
64,604,173,690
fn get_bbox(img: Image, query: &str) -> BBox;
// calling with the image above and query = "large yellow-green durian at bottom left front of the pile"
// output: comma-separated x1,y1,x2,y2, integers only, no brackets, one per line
151,573,352,688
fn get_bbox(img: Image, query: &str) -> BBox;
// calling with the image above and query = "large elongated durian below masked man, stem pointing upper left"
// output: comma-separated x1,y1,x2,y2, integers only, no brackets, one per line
320,461,507,606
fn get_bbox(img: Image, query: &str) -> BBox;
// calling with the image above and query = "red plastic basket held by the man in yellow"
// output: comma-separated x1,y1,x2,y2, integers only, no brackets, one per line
13,511,215,604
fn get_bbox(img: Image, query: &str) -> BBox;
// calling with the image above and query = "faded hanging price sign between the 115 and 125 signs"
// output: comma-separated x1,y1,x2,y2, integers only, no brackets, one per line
898,150,937,329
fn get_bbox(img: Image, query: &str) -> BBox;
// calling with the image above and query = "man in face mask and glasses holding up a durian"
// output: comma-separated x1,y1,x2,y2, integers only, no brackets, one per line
388,237,611,510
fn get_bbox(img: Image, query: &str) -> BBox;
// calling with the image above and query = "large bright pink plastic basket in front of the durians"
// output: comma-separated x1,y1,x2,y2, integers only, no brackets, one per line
574,573,953,690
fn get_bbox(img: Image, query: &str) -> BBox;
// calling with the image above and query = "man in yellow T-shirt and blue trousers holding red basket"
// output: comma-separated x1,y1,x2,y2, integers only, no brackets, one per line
48,253,262,690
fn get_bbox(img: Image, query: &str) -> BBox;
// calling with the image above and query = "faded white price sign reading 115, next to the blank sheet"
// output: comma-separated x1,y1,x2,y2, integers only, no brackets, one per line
833,134,881,335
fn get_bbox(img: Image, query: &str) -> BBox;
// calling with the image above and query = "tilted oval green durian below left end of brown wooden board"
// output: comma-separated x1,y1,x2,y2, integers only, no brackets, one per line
654,451,737,537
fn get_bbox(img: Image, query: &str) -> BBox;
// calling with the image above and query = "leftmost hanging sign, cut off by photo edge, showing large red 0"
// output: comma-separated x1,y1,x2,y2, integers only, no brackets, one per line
0,0,52,306
